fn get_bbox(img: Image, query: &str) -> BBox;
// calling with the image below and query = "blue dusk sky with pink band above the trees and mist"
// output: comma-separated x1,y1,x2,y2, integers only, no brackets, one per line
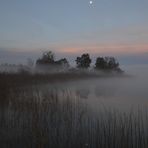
0,0,148,63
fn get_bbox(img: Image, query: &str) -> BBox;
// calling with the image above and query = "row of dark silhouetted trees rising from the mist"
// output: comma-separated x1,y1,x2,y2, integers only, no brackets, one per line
36,51,122,72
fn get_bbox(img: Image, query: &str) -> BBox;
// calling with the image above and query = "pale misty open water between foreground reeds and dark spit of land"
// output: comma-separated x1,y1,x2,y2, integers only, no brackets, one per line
46,65,148,111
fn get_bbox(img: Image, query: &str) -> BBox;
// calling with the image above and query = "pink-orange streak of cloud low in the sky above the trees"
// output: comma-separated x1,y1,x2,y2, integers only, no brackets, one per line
59,43,148,54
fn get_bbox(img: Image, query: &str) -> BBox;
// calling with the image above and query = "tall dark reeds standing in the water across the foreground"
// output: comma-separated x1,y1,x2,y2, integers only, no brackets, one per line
0,74,148,148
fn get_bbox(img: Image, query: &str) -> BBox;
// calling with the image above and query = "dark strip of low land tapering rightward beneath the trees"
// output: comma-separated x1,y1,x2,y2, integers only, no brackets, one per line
0,70,125,88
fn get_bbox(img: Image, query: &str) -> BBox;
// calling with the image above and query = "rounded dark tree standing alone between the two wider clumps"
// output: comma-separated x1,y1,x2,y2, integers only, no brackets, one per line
76,53,91,68
